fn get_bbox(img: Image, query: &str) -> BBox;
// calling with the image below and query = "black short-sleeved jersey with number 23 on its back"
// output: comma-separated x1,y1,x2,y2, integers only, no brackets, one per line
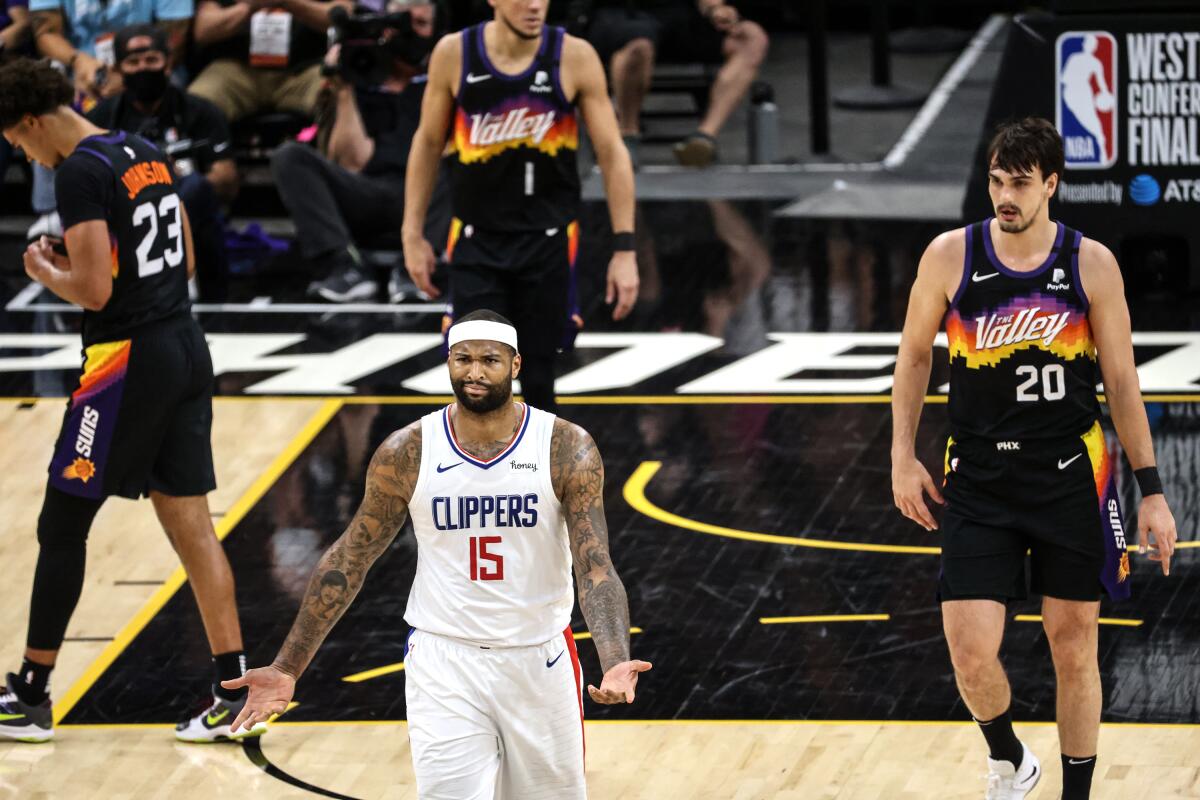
55,132,191,345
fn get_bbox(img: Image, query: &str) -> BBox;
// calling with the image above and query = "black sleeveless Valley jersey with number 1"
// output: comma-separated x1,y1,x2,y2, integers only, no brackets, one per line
452,23,580,230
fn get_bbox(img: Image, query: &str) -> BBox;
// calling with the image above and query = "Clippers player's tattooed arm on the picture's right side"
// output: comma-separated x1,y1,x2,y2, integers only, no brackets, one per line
551,420,629,672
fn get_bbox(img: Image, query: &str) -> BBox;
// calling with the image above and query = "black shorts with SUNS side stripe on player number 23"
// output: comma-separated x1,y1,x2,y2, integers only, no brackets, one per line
49,315,216,499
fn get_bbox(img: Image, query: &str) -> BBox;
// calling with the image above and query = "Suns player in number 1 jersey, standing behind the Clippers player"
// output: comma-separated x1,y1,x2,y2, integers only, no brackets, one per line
403,0,638,411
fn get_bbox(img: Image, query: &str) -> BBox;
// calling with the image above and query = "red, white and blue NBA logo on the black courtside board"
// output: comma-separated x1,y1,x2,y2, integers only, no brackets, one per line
1055,31,1117,169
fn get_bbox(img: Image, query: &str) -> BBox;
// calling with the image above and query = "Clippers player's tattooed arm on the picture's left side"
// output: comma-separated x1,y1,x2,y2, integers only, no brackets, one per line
274,422,421,678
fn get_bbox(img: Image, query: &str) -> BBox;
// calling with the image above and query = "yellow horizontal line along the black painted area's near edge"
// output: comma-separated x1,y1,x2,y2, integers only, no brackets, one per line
56,720,1200,735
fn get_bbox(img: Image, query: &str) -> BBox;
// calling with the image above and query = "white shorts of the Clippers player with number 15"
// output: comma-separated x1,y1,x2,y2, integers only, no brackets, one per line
404,628,587,800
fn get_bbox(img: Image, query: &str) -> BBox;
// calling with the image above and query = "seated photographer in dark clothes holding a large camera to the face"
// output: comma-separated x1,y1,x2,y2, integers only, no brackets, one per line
271,0,434,302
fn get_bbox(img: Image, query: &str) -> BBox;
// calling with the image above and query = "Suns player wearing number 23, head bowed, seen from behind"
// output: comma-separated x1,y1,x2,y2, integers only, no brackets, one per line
0,59,263,741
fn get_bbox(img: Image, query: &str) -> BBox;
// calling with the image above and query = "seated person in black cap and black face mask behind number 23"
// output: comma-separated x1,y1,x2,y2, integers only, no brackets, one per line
88,24,238,302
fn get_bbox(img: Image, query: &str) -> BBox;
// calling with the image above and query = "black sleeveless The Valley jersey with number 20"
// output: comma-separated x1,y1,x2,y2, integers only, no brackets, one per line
946,219,1100,441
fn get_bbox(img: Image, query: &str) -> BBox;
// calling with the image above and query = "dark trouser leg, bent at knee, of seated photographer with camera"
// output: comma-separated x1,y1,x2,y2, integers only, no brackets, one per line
271,142,404,260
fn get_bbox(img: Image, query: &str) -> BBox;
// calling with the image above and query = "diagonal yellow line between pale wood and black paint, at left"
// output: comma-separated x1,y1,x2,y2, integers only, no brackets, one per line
54,399,342,724
